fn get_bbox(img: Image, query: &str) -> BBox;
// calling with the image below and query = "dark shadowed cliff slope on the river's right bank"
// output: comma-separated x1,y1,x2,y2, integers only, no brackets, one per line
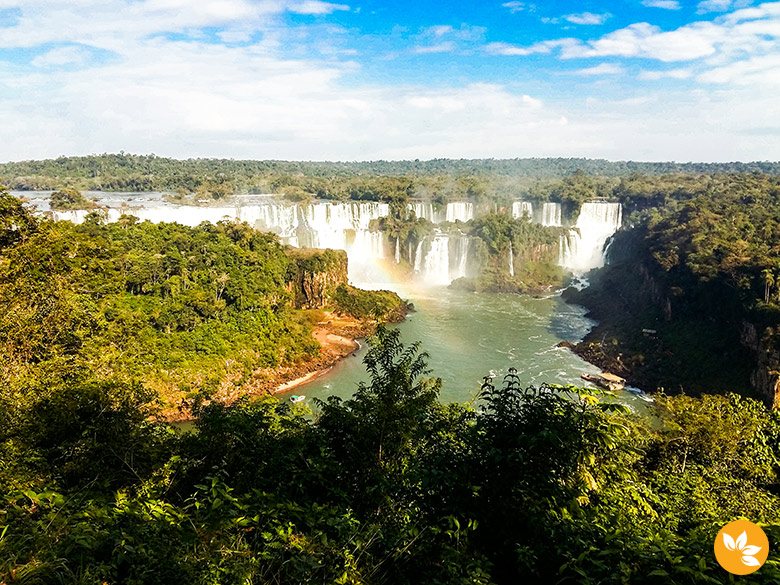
565,233,756,402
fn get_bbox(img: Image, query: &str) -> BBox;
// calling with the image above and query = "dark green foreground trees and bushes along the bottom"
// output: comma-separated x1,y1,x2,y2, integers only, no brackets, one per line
0,329,780,585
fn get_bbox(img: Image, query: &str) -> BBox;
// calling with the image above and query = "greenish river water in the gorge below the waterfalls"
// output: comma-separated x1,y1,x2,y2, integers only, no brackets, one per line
282,283,647,412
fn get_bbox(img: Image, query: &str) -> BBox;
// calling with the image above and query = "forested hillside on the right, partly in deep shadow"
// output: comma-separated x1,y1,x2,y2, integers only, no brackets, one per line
571,174,780,404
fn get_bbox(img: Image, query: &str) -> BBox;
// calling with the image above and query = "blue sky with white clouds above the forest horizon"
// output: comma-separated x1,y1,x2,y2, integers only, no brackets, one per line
0,0,780,161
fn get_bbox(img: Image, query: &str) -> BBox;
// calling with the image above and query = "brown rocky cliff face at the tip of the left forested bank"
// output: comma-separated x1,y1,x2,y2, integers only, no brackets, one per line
287,248,348,309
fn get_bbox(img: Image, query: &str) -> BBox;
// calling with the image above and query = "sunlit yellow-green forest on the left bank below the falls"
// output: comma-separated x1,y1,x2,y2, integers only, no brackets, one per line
0,192,401,416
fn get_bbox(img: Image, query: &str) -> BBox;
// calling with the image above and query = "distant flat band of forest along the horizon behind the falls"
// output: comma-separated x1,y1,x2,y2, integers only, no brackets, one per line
0,153,780,205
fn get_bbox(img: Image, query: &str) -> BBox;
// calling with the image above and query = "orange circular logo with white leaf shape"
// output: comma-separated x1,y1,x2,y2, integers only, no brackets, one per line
715,520,769,575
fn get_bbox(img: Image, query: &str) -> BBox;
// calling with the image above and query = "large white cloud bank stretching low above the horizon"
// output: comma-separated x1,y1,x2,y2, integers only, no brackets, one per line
0,45,780,160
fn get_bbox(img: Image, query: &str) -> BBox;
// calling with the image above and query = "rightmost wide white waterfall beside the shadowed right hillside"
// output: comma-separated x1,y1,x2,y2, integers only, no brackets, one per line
560,201,623,274
